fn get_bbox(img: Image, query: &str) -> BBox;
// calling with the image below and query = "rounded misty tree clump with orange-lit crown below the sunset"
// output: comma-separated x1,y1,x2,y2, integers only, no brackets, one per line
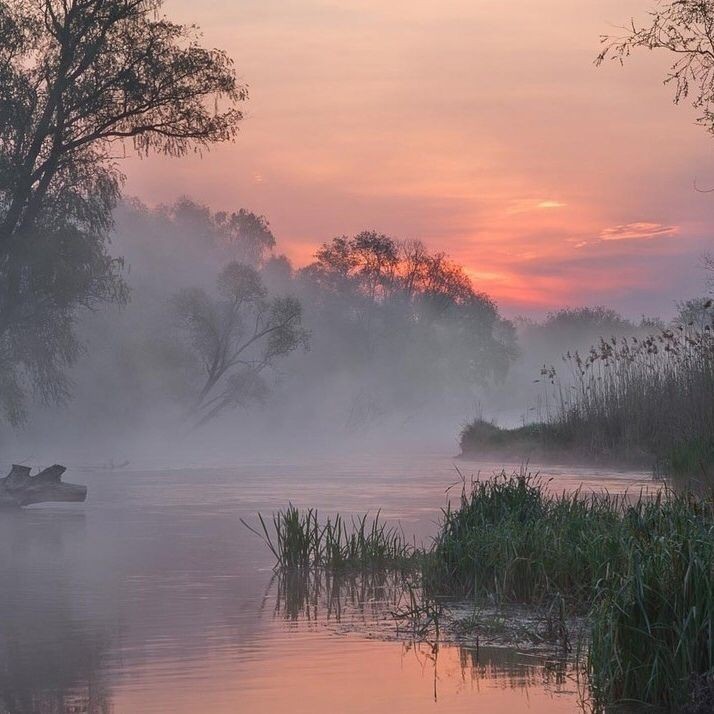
297,231,517,421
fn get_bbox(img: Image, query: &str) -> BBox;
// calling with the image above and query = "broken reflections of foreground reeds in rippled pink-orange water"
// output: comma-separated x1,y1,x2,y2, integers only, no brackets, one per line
261,569,587,710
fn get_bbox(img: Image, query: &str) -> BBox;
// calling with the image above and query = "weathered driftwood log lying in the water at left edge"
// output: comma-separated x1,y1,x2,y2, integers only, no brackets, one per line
0,464,87,507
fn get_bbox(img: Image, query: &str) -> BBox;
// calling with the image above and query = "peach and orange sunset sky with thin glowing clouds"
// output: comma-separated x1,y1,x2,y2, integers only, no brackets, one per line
123,0,714,317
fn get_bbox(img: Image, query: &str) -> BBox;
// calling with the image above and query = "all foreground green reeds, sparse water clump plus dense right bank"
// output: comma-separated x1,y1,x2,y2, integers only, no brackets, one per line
246,472,714,713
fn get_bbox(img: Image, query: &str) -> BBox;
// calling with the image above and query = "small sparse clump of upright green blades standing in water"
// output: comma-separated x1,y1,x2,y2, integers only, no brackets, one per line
242,504,416,570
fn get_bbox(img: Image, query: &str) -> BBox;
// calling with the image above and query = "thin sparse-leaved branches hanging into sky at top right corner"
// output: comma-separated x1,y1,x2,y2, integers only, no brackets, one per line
596,0,714,133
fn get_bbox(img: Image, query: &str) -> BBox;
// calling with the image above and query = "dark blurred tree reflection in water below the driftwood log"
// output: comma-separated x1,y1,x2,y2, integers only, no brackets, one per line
0,512,111,714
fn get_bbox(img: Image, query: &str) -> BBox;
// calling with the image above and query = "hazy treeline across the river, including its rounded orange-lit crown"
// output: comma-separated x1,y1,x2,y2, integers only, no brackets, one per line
47,199,517,436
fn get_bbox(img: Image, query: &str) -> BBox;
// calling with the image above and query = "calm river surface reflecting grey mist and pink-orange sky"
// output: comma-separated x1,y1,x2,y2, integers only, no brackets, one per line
0,454,648,714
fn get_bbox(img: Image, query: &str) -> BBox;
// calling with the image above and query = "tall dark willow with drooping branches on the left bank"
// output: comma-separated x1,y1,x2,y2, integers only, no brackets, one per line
0,0,246,421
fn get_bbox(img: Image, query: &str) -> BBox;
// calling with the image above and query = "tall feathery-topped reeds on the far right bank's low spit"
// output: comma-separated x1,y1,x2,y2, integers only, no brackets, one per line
460,324,714,487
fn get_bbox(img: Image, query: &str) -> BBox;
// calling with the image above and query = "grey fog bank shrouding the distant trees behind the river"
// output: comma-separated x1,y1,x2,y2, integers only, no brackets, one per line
4,198,708,467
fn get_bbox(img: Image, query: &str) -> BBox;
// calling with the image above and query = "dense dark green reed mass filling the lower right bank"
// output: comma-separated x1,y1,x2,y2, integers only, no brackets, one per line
426,474,714,711
